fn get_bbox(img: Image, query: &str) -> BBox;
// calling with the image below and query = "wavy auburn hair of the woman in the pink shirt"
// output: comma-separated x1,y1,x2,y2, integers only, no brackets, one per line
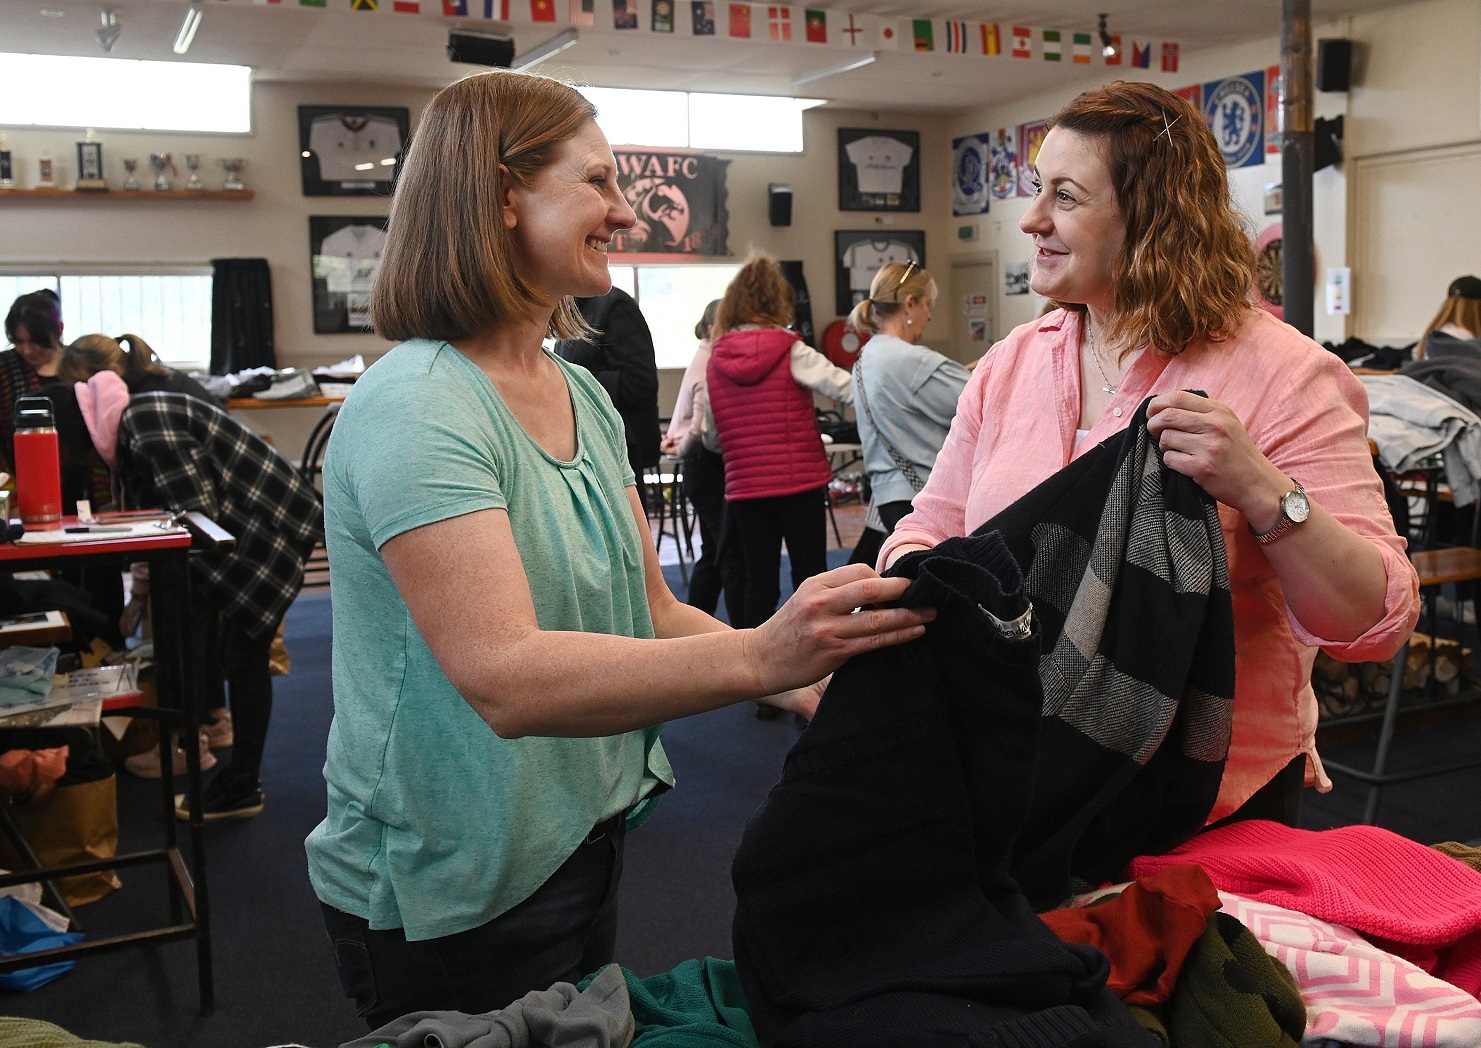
1049,80,1254,355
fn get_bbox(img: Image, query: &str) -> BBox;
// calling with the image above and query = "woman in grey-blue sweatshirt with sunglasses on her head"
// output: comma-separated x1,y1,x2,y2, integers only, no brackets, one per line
849,261,972,547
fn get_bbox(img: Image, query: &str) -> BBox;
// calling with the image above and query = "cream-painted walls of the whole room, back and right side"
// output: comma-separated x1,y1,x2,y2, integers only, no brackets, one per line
0,0,1481,450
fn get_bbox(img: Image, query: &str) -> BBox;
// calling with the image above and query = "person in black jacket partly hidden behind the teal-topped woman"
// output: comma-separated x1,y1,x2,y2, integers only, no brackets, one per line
555,287,662,509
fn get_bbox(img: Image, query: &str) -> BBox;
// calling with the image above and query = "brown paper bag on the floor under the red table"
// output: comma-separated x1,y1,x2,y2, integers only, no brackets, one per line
0,776,123,906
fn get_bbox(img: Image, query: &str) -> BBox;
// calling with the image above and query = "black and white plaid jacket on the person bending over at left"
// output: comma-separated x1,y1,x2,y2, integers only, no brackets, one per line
118,392,324,638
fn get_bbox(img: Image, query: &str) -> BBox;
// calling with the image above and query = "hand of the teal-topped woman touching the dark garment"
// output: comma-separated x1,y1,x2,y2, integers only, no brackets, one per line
746,564,936,694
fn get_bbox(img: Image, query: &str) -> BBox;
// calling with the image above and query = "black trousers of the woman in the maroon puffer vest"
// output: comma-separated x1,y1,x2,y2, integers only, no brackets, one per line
727,487,828,628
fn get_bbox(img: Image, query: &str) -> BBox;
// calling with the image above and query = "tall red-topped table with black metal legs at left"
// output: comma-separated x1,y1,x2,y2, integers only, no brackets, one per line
0,514,235,1015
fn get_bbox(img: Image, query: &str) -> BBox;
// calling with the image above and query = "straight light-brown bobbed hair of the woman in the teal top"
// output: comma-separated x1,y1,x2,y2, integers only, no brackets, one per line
370,70,597,342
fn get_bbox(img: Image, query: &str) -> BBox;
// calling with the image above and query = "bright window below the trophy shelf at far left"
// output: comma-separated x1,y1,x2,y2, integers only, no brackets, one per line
0,266,212,372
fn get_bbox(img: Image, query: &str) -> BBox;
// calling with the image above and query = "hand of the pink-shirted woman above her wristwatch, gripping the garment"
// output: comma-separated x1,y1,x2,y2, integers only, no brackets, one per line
1146,391,1290,528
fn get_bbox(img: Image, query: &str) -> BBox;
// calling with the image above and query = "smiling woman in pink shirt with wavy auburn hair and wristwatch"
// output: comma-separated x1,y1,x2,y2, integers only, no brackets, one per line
881,81,1419,824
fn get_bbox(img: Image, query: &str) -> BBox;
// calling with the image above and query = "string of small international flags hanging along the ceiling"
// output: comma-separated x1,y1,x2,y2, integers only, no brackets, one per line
252,0,1179,73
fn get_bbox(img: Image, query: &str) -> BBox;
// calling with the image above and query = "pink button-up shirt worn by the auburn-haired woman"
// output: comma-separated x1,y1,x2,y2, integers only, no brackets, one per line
880,309,1419,822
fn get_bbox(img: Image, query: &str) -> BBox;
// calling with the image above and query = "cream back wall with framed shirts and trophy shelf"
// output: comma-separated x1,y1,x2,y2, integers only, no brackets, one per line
0,81,952,435
